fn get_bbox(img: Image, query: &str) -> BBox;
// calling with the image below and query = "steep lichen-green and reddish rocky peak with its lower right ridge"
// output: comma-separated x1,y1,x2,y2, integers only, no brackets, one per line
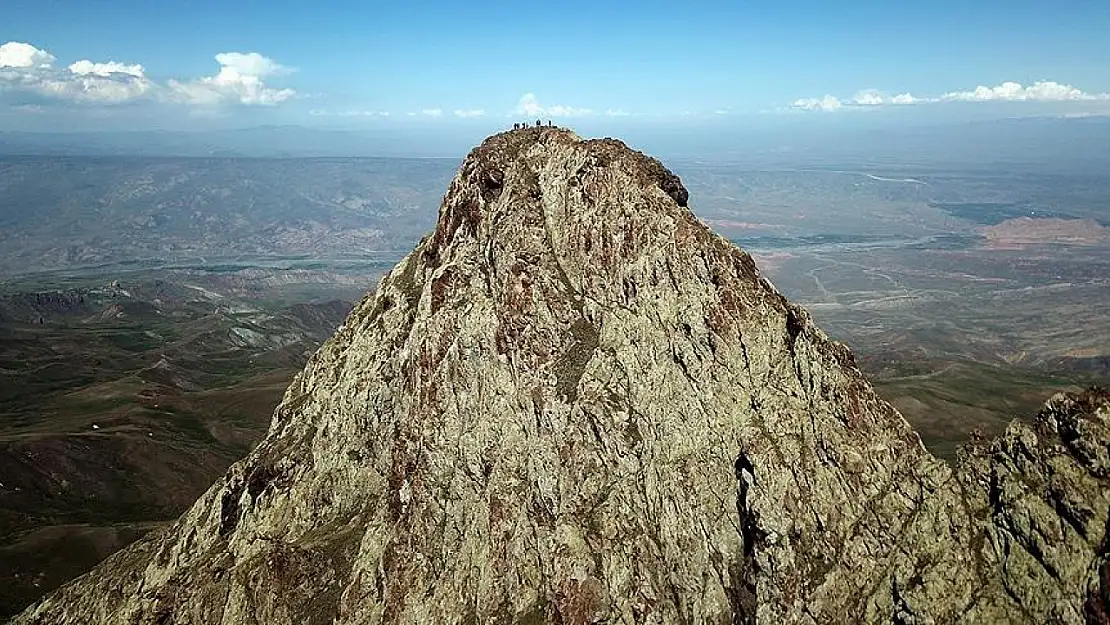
16,128,1110,625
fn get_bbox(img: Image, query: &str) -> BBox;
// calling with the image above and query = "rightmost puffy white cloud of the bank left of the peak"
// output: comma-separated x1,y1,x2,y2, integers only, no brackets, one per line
168,52,296,105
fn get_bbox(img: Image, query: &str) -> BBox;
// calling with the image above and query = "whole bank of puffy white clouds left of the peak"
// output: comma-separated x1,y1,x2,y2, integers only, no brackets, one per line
0,41,295,104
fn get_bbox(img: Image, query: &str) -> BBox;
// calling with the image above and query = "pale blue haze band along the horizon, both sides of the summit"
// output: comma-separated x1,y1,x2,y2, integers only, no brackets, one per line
0,118,1110,172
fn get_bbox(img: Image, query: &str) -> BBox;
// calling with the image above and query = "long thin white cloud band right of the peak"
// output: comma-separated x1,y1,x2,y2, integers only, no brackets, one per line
791,80,1110,111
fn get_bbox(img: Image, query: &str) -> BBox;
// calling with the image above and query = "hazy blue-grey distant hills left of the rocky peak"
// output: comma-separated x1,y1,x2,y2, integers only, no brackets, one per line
0,155,455,274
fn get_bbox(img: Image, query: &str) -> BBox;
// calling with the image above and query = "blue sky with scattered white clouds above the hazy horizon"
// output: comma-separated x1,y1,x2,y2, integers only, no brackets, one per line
0,0,1110,130
